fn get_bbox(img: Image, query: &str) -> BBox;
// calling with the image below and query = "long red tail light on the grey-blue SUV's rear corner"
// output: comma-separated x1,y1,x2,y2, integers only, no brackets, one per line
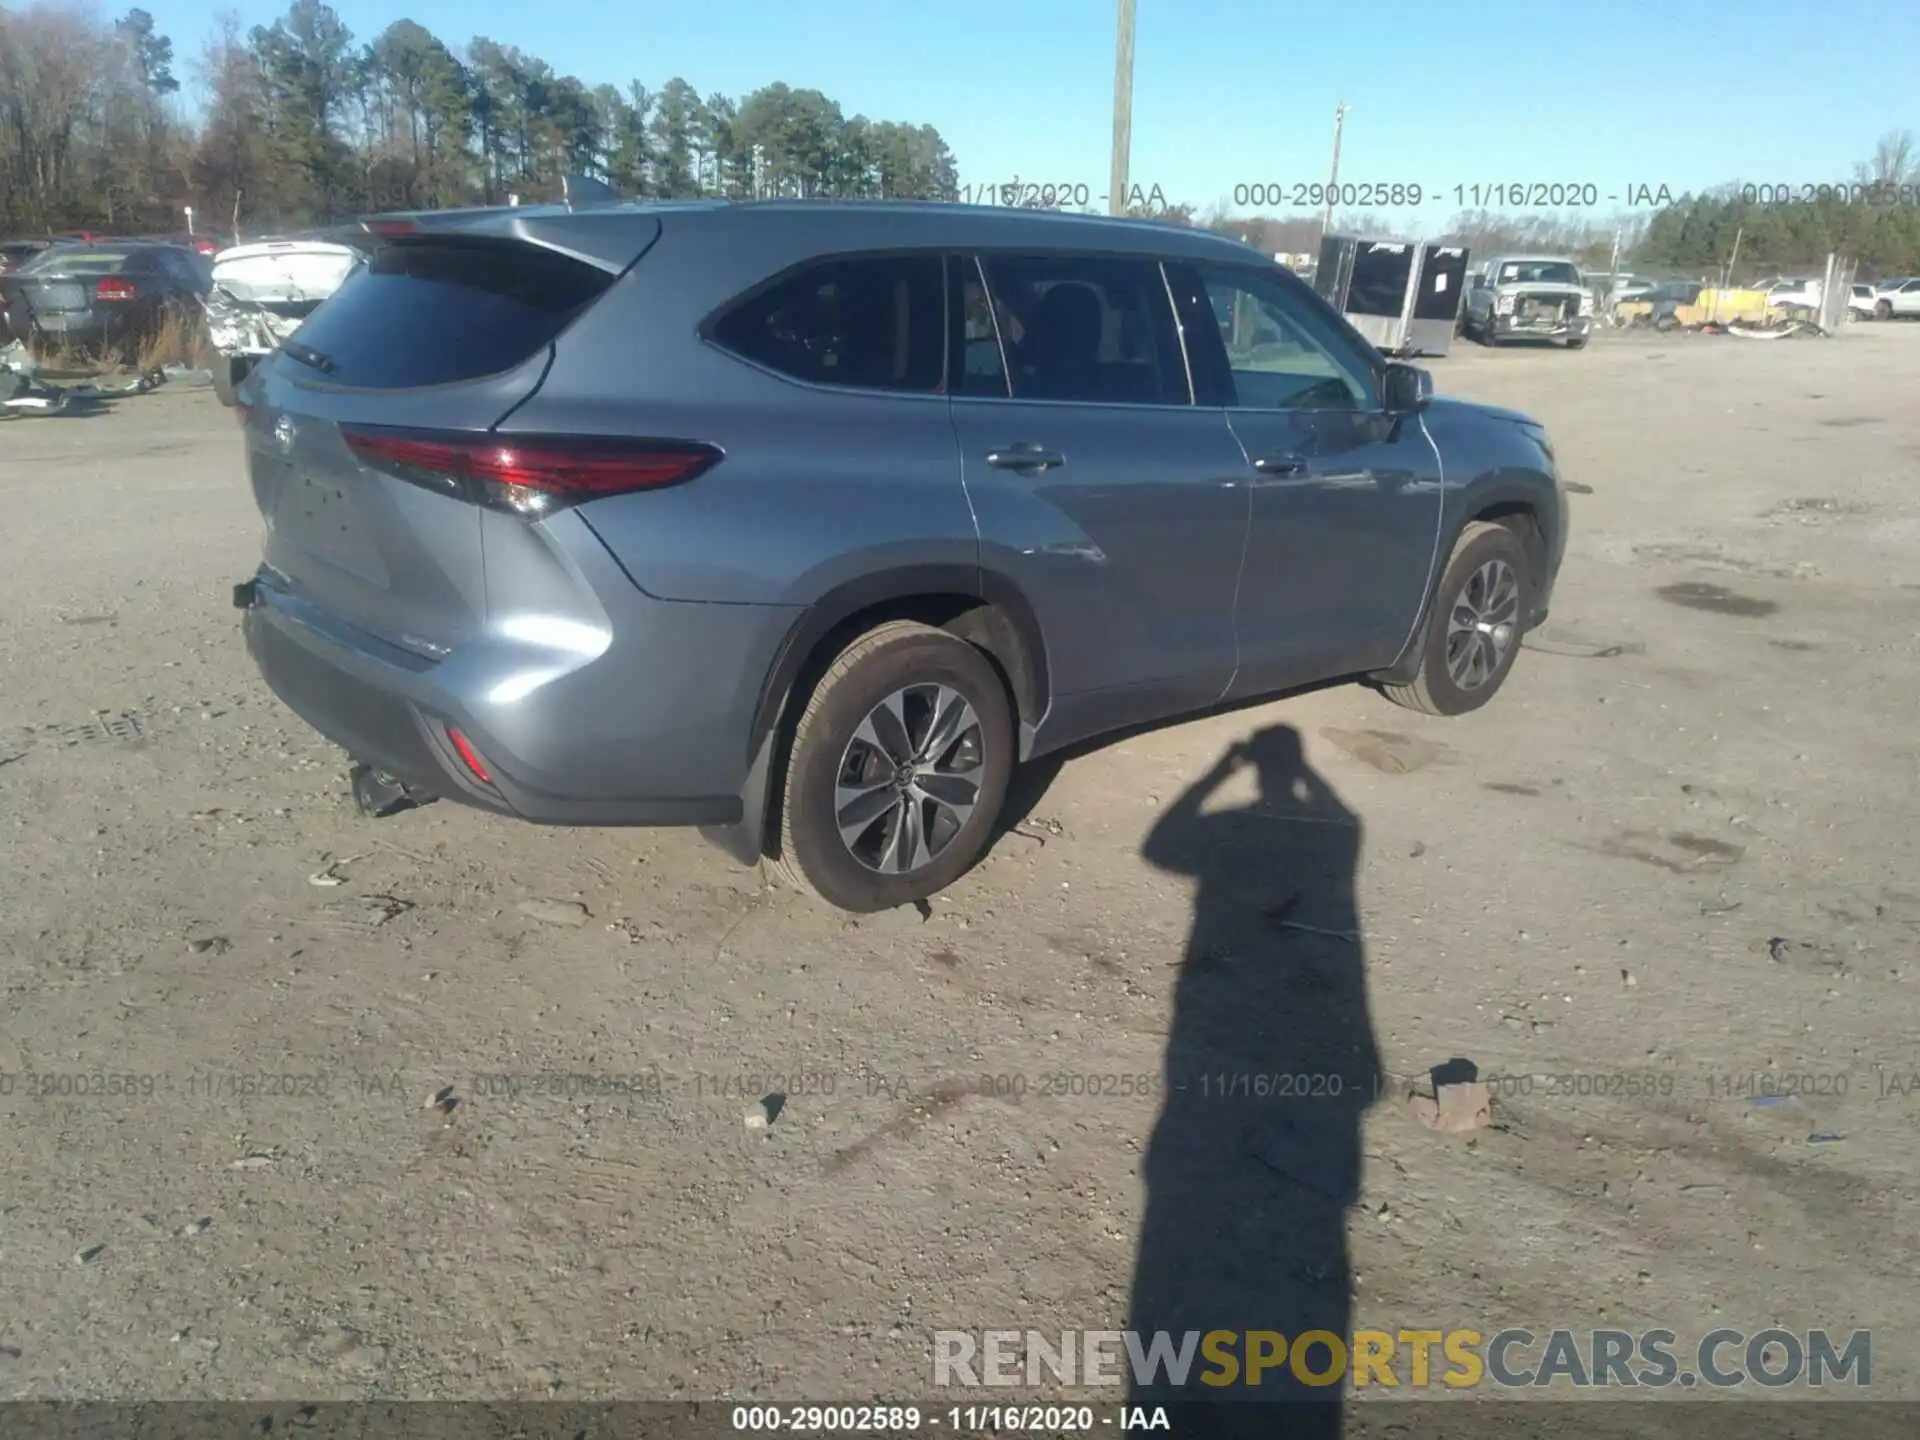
340,426,722,520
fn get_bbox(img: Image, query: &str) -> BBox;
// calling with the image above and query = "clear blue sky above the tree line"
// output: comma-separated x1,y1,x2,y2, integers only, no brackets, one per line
161,0,1920,228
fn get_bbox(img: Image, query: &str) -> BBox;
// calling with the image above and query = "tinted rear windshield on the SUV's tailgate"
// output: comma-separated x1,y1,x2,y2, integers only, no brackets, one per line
294,238,612,390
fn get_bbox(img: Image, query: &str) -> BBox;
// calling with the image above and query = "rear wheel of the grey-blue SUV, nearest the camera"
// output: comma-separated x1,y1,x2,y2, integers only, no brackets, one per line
776,620,1014,914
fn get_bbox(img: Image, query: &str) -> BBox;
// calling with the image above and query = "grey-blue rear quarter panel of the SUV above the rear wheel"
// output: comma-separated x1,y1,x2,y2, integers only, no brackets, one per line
501,223,979,605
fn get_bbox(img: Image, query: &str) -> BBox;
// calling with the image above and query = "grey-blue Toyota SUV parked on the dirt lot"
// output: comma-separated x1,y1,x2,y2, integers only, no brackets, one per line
234,202,1565,910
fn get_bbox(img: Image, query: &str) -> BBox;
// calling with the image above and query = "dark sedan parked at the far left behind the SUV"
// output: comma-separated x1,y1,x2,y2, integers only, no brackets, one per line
0,240,213,349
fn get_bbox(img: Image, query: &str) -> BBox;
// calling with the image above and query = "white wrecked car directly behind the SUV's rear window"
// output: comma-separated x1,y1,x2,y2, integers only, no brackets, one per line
205,232,369,405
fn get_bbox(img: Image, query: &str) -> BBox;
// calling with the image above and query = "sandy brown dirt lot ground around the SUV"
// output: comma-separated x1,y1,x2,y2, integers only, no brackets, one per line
0,326,1920,1400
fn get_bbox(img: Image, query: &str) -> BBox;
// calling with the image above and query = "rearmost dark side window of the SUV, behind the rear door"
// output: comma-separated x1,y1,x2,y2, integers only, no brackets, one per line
710,255,947,394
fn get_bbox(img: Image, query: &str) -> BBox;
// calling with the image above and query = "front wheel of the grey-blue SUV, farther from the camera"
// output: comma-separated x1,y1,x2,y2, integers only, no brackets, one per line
1382,520,1534,714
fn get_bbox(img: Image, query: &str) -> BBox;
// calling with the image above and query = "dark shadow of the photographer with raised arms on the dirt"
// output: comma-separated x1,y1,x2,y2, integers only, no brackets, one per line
1127,726,1379,1436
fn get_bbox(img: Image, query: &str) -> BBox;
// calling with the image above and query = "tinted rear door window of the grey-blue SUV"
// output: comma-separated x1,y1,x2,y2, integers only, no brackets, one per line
970,255,1192,405
